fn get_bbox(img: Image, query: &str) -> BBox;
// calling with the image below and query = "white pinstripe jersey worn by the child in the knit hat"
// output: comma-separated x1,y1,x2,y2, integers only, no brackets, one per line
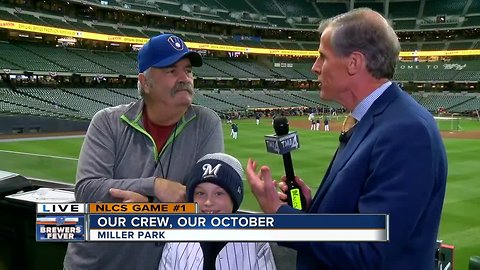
158,242,277,270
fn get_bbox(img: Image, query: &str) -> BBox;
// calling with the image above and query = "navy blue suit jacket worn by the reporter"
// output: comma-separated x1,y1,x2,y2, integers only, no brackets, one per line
278,84,447,270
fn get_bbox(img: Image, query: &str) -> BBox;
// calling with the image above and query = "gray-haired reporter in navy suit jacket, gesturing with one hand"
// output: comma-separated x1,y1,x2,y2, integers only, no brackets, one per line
247,8,447,270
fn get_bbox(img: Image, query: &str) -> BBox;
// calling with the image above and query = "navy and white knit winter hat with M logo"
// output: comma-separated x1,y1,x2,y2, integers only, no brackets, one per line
187,153,243,212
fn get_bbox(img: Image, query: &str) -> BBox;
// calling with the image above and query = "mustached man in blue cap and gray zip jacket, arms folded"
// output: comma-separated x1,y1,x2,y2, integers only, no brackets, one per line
64,34,224,270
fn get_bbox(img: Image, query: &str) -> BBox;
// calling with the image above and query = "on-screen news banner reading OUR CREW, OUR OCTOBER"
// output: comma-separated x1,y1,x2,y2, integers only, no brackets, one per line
36,203,389,242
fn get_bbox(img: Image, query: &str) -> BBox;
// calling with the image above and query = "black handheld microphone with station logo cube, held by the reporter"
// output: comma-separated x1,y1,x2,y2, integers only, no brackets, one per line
265,116,306,211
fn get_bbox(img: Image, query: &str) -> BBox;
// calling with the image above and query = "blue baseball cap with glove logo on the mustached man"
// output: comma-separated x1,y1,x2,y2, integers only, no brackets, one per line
138,34,203,73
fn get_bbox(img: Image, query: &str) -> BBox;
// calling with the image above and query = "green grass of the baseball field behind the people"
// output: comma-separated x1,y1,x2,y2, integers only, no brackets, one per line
0,118,480,269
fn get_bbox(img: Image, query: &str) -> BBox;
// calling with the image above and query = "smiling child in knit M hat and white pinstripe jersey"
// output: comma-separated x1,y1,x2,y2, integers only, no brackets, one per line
159,153,276,270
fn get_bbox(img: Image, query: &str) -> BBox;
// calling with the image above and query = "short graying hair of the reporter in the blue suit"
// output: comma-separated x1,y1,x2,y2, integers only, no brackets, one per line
318,8,400,79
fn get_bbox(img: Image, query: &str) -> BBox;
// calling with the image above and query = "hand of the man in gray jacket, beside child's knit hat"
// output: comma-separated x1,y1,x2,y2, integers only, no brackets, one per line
154,178,187,202
